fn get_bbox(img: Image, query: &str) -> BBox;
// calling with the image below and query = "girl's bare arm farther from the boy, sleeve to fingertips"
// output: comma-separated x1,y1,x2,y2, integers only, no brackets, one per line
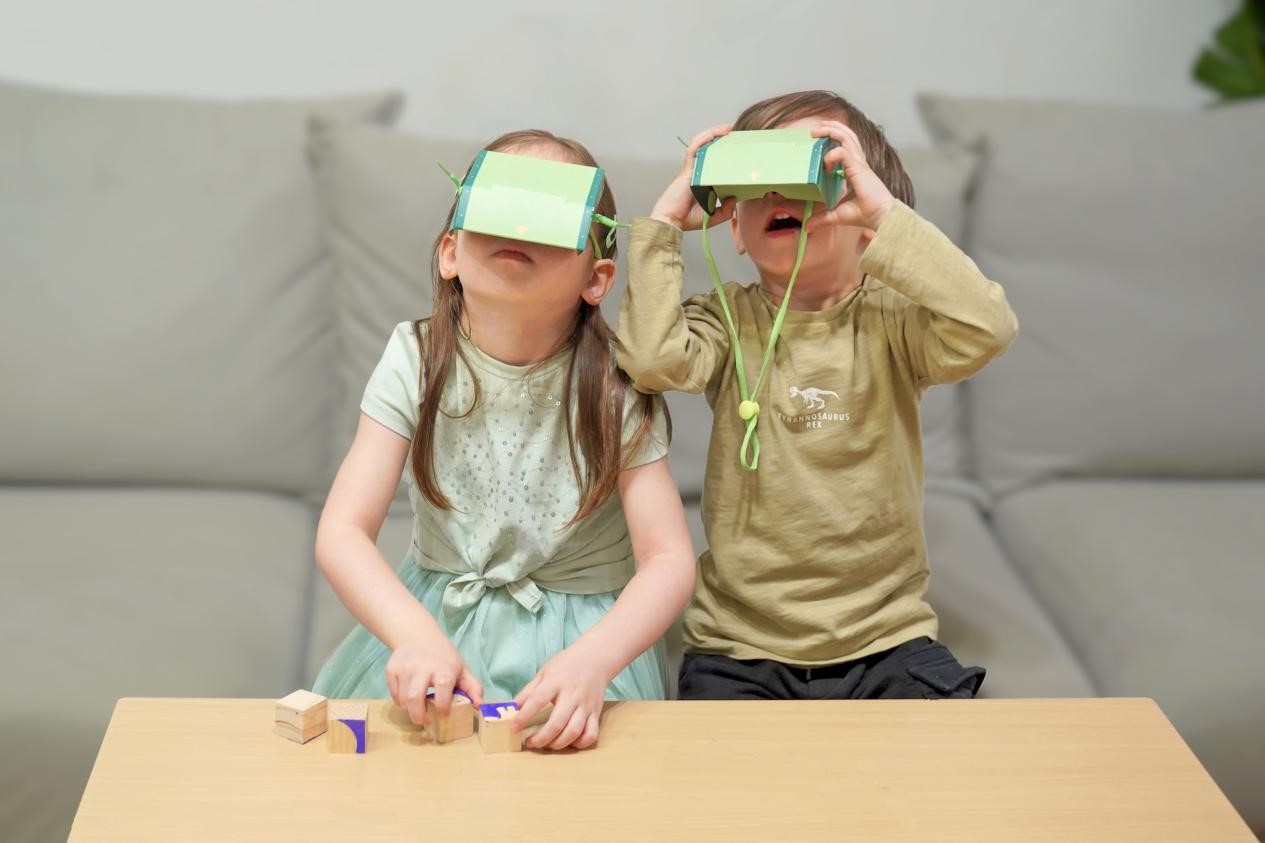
316,413,483,723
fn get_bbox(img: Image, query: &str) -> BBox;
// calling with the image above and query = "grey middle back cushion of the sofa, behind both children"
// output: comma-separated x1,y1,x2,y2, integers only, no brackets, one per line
311,120,975,499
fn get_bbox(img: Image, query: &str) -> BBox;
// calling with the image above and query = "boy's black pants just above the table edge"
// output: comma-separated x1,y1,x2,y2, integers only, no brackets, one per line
681,638,984,700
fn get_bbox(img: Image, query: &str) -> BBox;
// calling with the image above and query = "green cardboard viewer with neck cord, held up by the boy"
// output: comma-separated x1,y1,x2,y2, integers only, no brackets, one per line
689,129,844,471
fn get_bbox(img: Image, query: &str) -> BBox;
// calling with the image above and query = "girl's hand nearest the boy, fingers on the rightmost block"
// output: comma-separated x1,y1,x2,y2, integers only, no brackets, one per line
510,646,610,749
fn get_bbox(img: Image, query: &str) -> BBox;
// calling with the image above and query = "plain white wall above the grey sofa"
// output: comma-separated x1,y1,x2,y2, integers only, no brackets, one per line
0,0,1237,151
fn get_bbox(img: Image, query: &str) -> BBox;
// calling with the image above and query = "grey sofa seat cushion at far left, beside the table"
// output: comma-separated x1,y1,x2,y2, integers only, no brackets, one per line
0,486,315,840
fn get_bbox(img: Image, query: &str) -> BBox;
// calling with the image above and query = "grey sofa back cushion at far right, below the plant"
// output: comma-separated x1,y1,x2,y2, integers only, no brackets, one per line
922,97,1265,492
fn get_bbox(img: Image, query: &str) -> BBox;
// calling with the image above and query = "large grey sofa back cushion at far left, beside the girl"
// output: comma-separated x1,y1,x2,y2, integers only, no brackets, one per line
0,82,398,492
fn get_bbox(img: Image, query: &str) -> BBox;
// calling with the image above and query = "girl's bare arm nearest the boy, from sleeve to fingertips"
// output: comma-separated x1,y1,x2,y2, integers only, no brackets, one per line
512,458,694,749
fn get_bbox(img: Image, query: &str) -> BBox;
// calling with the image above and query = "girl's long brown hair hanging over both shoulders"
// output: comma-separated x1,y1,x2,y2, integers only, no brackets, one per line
410,129,654,527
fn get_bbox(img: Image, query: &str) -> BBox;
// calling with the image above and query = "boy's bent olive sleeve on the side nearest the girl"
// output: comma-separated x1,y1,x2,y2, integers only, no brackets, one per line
616,219,730,392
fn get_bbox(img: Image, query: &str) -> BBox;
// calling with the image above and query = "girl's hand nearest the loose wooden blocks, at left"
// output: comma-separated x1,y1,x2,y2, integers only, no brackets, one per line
387,637,483,725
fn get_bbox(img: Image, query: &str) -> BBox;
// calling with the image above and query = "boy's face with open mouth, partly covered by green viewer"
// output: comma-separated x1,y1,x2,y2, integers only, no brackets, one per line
731,114,873,289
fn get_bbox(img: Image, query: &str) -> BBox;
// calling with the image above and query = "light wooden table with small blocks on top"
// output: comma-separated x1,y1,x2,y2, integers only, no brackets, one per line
71,700,1255,843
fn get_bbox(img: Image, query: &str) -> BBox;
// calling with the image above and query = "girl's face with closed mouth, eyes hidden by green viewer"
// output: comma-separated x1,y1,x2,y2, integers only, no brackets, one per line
439,143,615,319
